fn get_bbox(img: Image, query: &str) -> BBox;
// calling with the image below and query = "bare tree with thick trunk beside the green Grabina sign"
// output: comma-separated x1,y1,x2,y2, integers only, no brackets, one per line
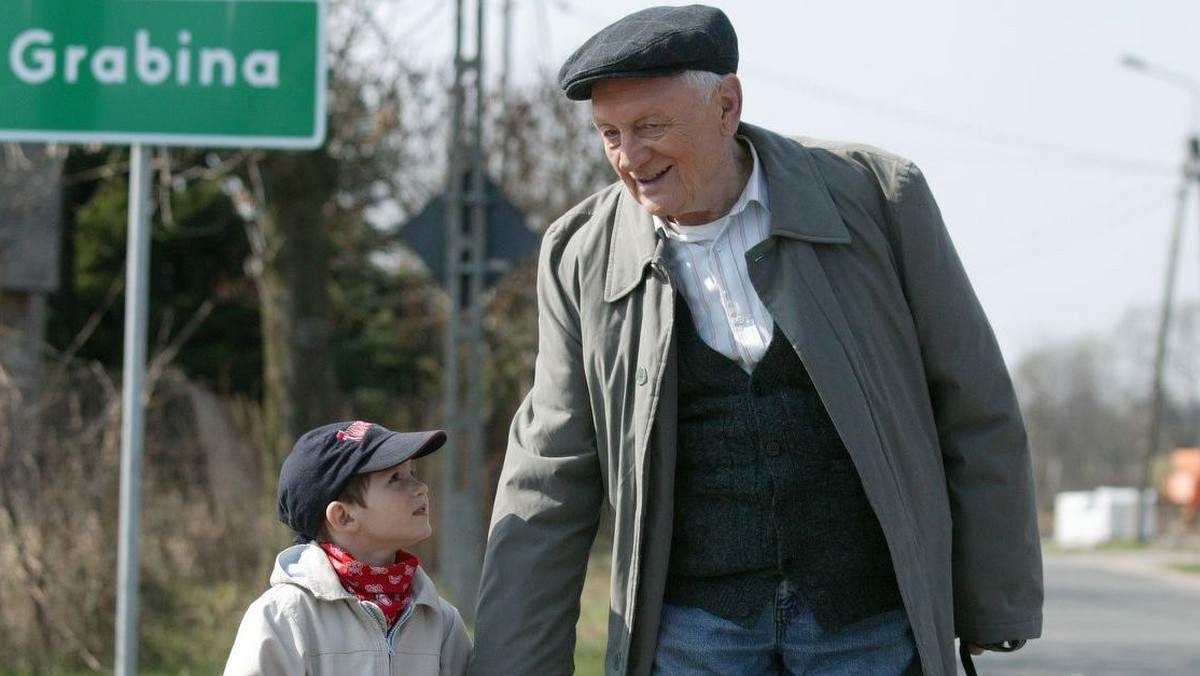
182,0,444,460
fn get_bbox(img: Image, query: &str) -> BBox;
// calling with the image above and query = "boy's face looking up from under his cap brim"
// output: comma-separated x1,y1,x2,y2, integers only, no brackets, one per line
356,460,433,551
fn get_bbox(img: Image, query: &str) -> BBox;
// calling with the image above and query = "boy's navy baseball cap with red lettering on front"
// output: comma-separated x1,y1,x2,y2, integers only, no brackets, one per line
277,420,446,540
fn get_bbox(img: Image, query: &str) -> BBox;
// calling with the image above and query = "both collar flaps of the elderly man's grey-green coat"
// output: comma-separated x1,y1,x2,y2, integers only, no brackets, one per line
604,124,850,303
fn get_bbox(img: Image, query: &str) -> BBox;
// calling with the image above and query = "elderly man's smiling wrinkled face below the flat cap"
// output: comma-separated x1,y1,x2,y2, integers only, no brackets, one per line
592,76,740,225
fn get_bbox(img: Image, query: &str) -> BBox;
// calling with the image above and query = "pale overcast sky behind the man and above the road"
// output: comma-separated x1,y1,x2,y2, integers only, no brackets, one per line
408,0,1200,360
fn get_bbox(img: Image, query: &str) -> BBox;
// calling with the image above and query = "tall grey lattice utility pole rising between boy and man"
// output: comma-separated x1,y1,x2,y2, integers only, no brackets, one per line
438,0,487,622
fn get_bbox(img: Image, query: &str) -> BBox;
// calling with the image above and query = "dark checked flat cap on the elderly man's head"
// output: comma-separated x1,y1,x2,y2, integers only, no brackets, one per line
558,5,738,101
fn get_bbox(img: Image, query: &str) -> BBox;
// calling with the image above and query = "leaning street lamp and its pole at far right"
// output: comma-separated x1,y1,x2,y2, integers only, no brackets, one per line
1121,54,1200,542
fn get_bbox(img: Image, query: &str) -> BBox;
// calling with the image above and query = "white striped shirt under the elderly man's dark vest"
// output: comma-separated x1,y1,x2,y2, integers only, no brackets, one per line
654,137,774,373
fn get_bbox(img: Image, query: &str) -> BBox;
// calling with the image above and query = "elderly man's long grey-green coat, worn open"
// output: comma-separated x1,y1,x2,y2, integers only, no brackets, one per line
468,125,1043,676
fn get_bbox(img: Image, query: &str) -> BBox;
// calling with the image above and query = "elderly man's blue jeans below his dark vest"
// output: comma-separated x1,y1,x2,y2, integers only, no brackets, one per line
652,582,920,676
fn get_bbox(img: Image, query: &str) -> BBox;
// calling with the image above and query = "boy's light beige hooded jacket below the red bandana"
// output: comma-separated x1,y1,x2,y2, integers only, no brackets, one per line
224,544,470,676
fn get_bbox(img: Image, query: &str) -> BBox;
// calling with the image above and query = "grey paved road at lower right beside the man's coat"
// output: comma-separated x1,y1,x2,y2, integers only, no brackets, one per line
960,551,1200,676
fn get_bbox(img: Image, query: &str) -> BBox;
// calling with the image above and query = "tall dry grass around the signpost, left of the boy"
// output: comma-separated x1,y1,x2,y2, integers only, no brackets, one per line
0,365,275,675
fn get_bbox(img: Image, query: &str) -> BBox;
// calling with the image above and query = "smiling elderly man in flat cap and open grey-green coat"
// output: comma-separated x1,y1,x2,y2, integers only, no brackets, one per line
469,5,1043,676
